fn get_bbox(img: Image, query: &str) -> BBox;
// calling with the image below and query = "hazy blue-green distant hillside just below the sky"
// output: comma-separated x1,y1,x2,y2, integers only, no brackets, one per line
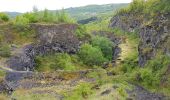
65,3,128,20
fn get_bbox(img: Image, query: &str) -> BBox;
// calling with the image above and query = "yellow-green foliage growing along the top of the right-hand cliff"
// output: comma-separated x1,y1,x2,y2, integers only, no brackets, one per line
117,0,170,15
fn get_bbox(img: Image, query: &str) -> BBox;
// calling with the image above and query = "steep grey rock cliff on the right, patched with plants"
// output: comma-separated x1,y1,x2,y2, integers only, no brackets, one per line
109,13,170,66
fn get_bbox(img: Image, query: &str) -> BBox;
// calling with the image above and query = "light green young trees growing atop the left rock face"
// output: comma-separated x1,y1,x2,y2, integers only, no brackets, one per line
13,8,74,26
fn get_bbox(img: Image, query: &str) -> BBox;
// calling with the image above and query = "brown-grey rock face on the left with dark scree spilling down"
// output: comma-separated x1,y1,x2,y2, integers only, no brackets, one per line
8,24,81,71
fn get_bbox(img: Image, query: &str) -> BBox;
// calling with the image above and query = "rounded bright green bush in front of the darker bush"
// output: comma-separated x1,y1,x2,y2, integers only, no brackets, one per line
78,44,106,66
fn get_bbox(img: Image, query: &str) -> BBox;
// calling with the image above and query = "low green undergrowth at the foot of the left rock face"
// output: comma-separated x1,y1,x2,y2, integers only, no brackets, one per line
36,53,76,71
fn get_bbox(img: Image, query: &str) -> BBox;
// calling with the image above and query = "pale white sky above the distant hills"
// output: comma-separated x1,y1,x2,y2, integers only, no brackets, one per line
0,0,132,12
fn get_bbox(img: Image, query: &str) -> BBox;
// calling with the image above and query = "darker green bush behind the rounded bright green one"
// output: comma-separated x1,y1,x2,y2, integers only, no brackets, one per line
91,36,114,60
